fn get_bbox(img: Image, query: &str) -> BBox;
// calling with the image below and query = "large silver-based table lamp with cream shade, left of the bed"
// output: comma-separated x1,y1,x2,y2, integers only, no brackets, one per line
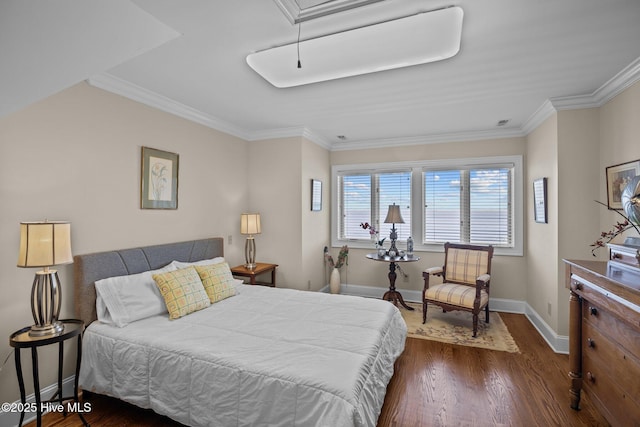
18,220,73,337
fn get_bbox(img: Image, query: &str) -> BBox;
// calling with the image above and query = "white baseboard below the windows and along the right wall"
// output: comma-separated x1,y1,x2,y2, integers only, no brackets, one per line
328,283,569,354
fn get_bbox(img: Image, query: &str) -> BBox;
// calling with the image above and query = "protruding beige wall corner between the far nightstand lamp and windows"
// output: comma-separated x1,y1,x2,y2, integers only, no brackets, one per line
249,138,330,290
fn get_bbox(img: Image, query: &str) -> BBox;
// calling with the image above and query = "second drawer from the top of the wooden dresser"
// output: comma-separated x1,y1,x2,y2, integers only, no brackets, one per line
582,300,640,360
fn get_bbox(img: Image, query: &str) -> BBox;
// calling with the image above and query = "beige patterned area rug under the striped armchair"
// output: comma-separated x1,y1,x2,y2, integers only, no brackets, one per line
400,303,520,353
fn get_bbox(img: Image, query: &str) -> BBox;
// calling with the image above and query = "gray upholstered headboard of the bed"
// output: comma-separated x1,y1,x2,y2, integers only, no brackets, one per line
73,237,224,326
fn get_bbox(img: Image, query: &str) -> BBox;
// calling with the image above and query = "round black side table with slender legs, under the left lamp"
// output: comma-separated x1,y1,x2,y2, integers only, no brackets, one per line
9,319,89,427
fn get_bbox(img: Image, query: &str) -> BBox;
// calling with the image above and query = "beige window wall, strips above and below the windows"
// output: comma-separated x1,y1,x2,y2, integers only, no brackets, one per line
331,138,527,301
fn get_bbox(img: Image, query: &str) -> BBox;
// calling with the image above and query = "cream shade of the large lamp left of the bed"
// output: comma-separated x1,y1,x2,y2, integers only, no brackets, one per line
18,221,73,267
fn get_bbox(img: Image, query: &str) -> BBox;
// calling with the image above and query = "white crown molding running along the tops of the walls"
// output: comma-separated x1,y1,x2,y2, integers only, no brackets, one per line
87,58,640,151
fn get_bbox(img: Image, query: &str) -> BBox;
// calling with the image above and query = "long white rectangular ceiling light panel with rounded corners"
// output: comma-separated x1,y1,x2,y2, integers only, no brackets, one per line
247,6,463,88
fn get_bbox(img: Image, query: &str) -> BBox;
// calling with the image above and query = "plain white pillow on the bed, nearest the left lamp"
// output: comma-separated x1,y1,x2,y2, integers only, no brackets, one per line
96,264,176,328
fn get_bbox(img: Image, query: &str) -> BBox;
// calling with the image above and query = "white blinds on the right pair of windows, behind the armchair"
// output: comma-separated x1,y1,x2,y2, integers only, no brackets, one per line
423,165,514,247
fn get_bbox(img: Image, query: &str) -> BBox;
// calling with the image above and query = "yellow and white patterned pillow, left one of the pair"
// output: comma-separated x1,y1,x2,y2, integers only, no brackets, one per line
153,267,211,319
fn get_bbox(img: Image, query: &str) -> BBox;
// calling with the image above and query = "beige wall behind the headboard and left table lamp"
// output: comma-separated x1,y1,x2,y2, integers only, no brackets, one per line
0,83,249,402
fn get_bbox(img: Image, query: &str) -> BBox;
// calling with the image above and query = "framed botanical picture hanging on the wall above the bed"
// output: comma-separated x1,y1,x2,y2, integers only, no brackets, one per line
140,147,179,209
